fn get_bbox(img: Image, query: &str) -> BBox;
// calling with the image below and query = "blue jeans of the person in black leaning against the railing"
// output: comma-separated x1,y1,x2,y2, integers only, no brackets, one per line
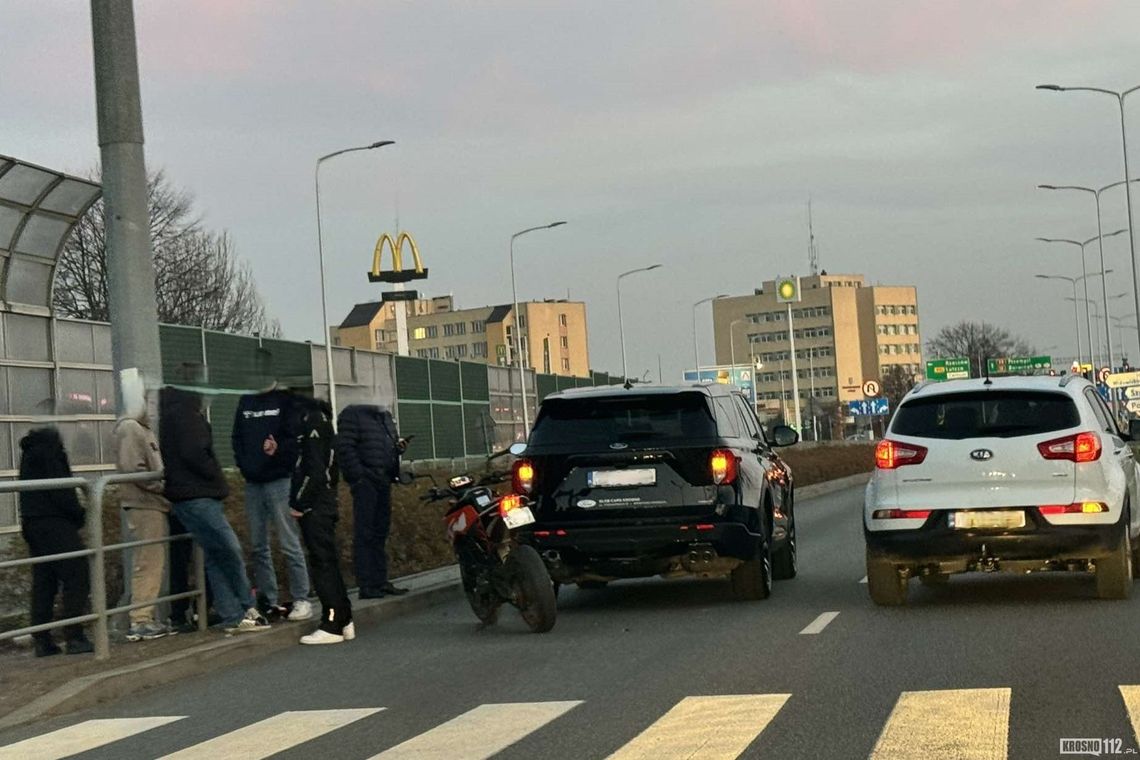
173,499,254,626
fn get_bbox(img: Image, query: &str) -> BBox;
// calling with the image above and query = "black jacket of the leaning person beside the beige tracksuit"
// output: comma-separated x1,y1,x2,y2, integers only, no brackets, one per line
158,387,229,501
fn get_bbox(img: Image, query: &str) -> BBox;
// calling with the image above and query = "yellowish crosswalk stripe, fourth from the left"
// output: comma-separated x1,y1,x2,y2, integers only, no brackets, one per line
610,694,791,760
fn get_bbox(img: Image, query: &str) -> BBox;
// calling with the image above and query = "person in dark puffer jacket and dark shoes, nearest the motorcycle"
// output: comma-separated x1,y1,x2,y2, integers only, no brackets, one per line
336,404,407,599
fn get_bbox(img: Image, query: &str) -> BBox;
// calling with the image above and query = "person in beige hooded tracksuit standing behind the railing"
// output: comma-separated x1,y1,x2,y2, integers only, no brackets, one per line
115,374,171,641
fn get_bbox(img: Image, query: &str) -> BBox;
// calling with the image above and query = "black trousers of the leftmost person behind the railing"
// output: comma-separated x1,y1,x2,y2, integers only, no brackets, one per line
23,517,90,641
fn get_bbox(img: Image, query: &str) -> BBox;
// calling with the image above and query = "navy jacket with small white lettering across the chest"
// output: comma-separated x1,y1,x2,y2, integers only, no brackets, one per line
231,391,296,483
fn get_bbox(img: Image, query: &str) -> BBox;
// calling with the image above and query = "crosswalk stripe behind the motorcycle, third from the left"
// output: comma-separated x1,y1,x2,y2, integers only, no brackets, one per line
372,701,581,760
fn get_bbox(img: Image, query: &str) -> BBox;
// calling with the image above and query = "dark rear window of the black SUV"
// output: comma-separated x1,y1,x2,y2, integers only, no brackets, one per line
530,393,716,446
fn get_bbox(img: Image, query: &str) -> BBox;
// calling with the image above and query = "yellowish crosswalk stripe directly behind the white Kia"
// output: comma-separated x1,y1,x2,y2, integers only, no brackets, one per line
871,688,1010,760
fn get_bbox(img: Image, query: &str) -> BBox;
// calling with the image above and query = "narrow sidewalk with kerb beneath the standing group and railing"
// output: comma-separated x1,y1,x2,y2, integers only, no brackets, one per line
0,565,461,730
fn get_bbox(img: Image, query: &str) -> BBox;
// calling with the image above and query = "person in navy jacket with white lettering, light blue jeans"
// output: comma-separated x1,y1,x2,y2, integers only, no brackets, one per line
231,385,312,621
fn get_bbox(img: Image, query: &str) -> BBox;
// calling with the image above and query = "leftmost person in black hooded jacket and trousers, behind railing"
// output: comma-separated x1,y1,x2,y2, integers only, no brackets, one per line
19,427,95,657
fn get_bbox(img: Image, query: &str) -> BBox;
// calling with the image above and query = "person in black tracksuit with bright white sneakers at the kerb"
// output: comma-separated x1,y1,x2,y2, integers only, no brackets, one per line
288,395,356,644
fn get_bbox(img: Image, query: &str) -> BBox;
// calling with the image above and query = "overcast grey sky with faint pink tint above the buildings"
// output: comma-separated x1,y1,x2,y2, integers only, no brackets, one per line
0,0,1140,377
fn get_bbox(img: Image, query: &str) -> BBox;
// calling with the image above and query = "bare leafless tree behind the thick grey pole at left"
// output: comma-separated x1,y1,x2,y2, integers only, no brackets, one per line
52,171,280,337
